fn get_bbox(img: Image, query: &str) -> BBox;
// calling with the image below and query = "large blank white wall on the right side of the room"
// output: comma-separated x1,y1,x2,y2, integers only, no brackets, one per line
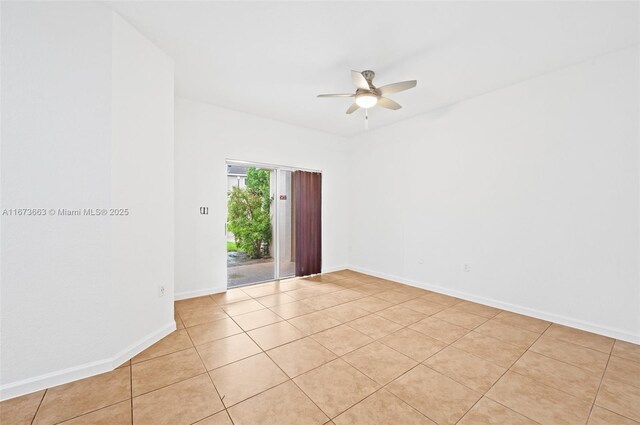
350,46,640,342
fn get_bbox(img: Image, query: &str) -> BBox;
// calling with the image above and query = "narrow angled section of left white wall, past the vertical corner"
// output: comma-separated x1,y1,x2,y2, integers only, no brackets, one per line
111,14,175,363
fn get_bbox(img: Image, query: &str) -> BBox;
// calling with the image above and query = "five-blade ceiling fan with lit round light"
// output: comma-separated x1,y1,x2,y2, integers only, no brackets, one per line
318,70,418,125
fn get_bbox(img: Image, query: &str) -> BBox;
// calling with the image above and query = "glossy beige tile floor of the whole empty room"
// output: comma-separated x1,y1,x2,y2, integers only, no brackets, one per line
0,270,640,425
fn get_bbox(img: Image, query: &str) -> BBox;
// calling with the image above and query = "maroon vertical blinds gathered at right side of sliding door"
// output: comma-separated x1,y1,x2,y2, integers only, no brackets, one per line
293,171,322,276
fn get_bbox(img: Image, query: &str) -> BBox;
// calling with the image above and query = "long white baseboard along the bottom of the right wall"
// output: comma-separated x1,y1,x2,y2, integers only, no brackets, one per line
346,266,640,344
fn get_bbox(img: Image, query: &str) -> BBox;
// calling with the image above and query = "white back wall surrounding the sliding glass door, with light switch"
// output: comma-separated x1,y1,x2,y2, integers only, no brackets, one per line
175,99,349,298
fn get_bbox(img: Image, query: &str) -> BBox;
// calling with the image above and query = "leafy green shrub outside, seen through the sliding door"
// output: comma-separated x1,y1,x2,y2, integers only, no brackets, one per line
227,168,272,258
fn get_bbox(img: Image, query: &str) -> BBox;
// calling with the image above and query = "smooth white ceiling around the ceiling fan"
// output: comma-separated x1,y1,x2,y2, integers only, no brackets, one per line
107,1,639,136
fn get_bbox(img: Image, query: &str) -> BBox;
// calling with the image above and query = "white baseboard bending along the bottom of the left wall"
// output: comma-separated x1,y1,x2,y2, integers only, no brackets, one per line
0,320,176,401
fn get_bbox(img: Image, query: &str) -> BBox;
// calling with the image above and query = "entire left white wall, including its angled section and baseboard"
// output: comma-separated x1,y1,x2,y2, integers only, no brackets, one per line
0,2,175,399
